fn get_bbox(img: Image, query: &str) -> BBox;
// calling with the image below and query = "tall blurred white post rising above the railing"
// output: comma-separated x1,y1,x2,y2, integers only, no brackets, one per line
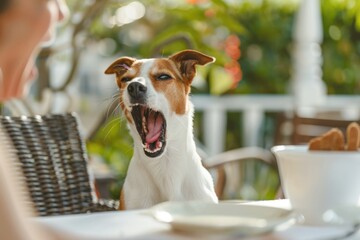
292,0,327,107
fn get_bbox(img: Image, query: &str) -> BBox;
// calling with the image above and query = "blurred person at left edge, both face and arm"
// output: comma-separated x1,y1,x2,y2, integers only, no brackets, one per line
0,0,72,240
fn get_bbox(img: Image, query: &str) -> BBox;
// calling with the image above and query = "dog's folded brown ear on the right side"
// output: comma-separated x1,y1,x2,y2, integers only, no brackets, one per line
169,50,215,81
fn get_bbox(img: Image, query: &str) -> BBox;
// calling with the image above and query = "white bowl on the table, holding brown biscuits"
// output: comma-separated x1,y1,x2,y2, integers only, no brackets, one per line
271,145,360,225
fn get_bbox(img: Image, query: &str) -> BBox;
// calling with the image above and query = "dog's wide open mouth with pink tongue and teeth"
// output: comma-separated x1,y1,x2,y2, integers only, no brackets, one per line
131,105,166,157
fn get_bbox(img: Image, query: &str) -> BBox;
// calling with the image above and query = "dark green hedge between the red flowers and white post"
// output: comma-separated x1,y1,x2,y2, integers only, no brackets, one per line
232,1,294,93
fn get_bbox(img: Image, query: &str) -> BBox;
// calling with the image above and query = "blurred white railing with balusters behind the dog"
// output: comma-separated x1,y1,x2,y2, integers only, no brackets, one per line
191,95,360,154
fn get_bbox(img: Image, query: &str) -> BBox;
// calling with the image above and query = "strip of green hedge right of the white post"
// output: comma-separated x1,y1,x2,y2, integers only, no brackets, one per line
322,1,360,94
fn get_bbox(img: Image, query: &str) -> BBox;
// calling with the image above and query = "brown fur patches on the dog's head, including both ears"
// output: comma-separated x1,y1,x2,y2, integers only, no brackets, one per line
105,50,215,116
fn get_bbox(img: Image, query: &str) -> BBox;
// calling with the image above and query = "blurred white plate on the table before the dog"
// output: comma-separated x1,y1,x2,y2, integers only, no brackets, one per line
152,201,297,236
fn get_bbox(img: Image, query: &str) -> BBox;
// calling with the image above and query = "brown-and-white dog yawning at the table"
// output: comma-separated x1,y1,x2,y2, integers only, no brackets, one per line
105,50,218,210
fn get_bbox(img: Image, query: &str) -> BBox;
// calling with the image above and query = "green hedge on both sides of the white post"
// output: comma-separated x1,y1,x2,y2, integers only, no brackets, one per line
235,0,360,94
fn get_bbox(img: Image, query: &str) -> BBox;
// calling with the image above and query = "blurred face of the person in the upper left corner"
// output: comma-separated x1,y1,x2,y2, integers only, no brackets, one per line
0,0,68,102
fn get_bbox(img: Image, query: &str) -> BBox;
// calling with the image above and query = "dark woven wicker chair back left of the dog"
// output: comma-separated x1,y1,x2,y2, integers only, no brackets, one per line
0,114,118,216
